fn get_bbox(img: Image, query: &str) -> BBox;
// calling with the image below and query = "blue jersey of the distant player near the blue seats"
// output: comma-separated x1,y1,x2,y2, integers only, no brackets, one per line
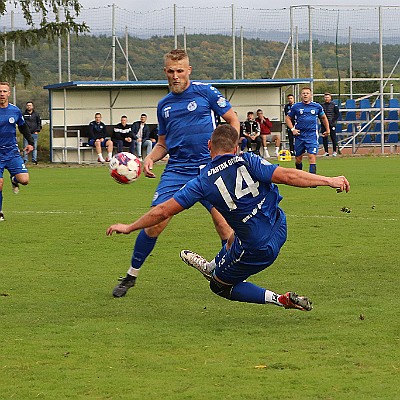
287,101,324,136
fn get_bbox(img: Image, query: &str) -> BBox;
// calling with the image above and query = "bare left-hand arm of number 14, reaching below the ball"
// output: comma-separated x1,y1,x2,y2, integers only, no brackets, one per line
106,199,184,236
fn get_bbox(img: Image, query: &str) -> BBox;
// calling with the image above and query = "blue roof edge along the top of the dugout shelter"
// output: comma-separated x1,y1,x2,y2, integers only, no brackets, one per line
43,78,312,90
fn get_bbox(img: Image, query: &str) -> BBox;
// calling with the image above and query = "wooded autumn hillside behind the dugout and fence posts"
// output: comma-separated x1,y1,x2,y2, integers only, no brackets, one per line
17,35,400,118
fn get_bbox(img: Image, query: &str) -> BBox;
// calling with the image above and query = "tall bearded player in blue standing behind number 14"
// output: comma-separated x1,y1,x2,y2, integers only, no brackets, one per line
113,49,240,297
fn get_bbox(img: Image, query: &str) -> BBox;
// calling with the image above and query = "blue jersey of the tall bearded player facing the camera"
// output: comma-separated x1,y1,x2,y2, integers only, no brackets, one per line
157,82,231,168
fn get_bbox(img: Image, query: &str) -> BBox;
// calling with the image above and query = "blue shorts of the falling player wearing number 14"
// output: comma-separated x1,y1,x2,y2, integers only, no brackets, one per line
214,211,287,285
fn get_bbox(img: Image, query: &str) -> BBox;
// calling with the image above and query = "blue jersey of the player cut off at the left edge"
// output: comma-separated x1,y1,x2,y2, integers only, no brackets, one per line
0,104,25,161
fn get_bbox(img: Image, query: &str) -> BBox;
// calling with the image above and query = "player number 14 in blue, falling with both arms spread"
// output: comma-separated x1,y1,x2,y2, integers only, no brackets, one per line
106,125,350,311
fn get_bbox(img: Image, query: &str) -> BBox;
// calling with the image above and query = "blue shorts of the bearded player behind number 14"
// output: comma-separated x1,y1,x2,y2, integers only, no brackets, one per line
151,167,213,211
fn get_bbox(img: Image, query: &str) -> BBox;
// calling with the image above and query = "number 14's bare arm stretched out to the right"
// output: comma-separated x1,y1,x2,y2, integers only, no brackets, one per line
272,167,350,193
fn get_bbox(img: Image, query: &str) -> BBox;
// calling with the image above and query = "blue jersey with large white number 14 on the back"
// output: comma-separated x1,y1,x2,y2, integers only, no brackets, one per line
174,153,283,249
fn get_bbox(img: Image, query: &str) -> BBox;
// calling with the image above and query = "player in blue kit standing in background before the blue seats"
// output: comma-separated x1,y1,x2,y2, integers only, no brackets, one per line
285,87,330,174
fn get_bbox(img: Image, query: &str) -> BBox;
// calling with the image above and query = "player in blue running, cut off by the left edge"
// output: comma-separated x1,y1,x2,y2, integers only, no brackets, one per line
0,82,34,221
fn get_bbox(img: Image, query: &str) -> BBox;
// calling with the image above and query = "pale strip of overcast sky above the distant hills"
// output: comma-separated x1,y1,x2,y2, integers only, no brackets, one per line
80,0,399,12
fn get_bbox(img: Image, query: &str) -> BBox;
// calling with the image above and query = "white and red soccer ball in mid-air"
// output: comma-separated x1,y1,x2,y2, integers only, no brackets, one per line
109,151,142,184
